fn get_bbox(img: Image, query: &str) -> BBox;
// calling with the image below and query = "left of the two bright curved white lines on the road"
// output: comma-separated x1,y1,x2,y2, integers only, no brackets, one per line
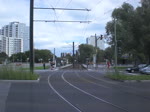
48,73,82,112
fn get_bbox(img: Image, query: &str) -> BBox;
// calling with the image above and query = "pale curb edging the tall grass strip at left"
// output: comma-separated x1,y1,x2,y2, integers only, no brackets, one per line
0,78,40,83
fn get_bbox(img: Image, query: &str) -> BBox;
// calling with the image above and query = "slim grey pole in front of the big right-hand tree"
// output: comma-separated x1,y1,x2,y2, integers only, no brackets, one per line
114,18,117,72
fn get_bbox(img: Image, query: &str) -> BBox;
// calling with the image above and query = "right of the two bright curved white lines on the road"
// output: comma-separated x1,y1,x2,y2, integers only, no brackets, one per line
61,74,128,112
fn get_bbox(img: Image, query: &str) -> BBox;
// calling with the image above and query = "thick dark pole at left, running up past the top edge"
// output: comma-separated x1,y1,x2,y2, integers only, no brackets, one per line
30,0,34,73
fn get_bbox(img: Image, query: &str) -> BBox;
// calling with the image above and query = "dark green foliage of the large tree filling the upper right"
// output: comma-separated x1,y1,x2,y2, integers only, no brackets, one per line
106,0,150,62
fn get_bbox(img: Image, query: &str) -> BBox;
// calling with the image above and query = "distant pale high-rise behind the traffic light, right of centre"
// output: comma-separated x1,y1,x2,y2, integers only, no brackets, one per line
86,36,105,50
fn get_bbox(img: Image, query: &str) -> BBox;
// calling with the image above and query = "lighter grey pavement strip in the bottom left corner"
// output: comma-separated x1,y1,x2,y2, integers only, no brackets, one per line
0,81,11,112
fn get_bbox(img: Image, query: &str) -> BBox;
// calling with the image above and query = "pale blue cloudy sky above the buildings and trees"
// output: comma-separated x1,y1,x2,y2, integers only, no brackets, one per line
0,0,140,56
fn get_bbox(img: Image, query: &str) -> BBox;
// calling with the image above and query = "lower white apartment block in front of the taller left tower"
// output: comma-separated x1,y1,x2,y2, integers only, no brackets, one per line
0,35,23,56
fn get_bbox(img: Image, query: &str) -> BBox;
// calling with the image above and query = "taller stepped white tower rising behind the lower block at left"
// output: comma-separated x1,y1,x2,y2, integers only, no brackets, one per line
0,22,29,52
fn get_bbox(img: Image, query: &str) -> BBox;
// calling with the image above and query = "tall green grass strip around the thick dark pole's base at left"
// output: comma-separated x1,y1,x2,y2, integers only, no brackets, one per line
0,66,39,80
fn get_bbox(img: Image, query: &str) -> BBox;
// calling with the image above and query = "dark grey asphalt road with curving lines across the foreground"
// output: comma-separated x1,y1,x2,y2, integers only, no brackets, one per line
5,70,150,112
